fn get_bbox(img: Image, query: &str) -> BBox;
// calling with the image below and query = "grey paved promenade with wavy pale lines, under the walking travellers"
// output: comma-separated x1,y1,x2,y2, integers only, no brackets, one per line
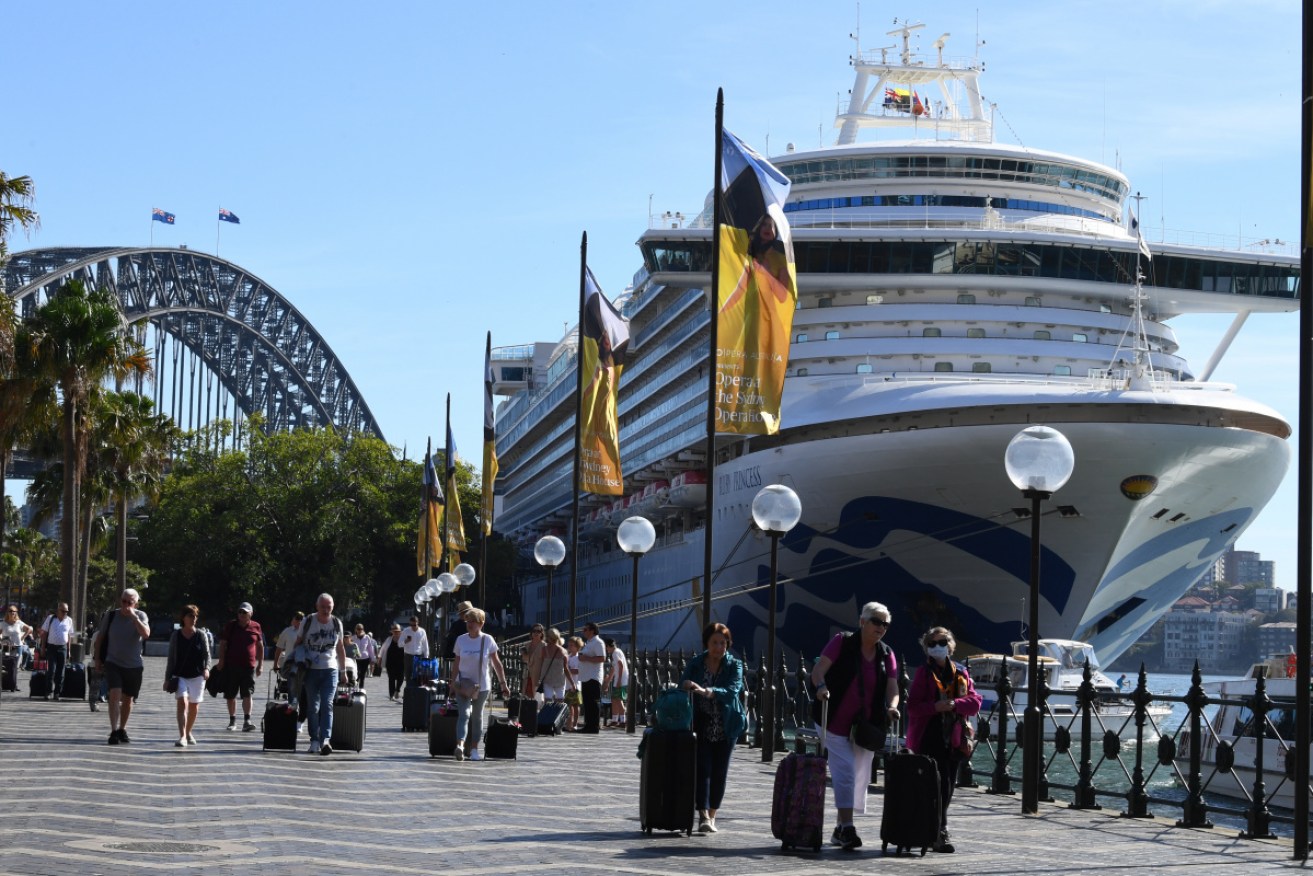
0,658,1299,876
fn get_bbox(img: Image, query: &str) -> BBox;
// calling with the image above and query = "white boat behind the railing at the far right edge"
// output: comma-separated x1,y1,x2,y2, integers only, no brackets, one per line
1176,654,1296,809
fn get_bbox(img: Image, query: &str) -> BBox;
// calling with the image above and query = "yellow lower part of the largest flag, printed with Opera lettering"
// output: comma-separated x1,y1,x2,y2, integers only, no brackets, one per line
716,210,798,435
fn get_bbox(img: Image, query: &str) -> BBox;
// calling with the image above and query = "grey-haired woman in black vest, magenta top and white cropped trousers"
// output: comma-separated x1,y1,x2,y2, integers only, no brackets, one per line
811,603,898,851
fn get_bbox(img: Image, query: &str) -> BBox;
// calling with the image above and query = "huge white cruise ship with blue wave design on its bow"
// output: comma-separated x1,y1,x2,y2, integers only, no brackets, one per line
492,24,1300,665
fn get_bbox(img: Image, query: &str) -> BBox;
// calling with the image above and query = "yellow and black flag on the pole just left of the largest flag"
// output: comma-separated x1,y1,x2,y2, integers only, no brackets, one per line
579,268,629,495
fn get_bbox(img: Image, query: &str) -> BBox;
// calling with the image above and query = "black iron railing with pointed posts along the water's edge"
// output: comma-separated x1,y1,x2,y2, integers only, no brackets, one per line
503,646,1308,839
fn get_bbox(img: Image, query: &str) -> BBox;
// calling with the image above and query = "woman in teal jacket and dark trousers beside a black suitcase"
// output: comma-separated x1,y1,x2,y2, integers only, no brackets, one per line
680,624,747,834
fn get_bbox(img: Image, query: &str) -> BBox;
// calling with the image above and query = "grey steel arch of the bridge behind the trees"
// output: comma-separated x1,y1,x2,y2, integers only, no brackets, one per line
4,247,383,439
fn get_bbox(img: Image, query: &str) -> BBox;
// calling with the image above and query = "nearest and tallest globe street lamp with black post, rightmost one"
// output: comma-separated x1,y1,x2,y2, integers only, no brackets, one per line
1003,426,1075,814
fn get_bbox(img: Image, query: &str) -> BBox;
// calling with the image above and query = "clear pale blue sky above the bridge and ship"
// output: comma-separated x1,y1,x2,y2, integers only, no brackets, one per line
0,0,1300,588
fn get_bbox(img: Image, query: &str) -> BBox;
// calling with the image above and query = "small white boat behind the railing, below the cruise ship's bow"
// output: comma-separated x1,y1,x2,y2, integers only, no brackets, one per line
966,638,1171,741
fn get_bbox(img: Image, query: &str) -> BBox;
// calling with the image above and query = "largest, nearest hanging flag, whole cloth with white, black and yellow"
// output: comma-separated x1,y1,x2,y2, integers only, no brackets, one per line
714,129,798,435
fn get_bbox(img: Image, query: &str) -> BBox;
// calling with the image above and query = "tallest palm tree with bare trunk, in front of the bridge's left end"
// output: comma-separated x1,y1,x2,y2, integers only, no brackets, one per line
20,280,151,638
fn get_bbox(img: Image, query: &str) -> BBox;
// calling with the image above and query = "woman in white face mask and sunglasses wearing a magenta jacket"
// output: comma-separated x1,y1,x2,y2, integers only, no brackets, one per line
907,626,981,852
